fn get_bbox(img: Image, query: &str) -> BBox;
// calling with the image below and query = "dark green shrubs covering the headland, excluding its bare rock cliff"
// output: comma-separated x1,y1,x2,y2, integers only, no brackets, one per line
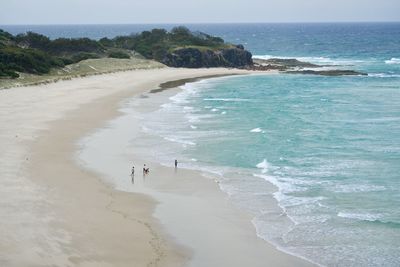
0,26,231,78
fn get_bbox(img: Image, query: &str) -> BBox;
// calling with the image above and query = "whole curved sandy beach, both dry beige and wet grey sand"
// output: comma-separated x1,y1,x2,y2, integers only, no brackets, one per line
0,68,311,266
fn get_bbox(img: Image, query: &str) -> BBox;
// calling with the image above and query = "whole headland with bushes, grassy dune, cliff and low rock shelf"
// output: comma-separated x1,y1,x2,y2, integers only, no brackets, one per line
0,26,363,87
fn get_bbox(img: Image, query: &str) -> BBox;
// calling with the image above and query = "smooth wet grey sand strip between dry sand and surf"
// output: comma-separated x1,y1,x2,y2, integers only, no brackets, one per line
77,71,314,266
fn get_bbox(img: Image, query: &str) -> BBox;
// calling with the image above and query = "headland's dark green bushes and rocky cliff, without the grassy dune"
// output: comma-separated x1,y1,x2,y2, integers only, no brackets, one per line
0,27,252,78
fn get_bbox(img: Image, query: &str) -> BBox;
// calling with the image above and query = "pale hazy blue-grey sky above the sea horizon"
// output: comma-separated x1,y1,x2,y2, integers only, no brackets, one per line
0,0,400,24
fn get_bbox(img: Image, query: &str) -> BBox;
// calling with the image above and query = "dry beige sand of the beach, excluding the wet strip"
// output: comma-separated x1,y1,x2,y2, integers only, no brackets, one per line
0,68,312,266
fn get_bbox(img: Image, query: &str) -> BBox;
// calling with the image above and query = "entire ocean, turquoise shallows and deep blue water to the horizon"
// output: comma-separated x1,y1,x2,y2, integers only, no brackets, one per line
1,23,400,266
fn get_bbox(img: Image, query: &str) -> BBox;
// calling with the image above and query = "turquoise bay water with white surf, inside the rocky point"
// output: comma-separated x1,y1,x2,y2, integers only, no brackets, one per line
144,74,400,266
